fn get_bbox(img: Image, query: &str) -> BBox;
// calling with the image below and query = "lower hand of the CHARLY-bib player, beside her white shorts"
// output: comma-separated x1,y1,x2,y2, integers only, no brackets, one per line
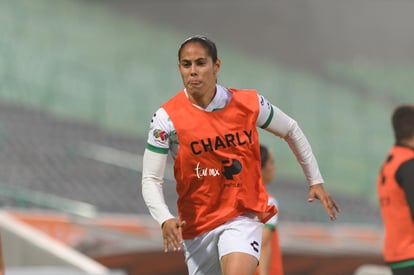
161,218,185,252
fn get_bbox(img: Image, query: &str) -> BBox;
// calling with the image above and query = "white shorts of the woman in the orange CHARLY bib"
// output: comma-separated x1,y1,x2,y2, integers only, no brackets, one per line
184,215,263,275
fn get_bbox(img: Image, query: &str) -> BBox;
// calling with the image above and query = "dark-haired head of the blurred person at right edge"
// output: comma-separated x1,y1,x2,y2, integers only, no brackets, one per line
392,105,414,144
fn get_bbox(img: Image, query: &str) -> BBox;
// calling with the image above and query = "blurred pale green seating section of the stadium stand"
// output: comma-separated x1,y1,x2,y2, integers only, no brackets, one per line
0,1,389,209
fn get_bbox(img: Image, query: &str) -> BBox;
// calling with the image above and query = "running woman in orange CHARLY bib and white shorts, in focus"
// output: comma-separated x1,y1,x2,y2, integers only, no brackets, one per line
142,36,339,275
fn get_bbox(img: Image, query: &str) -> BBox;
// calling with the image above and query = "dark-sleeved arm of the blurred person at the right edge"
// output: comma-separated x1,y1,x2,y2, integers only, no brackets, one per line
395,159,414,221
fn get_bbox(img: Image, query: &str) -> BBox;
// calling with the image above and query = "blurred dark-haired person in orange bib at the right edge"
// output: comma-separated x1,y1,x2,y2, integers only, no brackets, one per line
377,105,414,275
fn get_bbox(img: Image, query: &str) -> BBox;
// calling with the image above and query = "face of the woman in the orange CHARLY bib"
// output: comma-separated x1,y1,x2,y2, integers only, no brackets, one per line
178,42,220,107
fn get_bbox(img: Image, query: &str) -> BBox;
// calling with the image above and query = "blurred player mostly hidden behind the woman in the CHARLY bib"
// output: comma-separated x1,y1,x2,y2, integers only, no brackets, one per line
256,145,283,275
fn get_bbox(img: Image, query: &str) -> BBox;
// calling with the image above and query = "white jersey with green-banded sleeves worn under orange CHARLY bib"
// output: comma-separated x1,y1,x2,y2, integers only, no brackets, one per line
142,85,323,225
